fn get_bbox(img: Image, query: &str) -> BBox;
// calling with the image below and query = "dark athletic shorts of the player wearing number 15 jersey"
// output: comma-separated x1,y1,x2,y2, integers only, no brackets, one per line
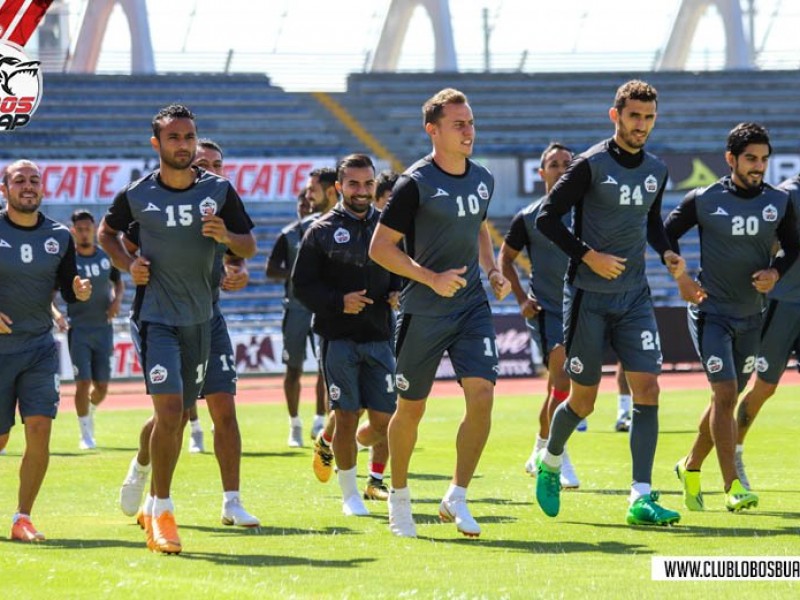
131,320,211,410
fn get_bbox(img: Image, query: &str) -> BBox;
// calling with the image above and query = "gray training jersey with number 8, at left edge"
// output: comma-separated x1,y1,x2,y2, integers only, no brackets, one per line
0,212,76,354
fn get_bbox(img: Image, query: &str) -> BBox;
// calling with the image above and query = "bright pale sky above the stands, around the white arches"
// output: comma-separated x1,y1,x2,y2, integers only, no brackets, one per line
67,0,800,89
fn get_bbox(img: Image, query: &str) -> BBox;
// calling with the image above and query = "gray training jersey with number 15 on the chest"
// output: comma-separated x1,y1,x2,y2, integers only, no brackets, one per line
105,170,253,326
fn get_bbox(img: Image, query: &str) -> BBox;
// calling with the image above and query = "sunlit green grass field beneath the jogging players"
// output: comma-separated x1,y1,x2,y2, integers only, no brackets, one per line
0,386,800,600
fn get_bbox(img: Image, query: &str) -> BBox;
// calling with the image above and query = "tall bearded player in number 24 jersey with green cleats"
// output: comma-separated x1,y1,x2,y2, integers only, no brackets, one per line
536,80,685,525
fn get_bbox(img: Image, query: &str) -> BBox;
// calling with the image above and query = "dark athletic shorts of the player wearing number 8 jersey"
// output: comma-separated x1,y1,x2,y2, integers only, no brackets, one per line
0,342,59,435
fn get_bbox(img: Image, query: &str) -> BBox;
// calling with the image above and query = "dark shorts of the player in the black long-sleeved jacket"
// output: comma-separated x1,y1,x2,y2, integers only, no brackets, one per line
321,339,397,414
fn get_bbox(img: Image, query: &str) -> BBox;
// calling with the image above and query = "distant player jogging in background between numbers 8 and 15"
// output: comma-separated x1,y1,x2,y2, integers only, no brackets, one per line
61,210,125,450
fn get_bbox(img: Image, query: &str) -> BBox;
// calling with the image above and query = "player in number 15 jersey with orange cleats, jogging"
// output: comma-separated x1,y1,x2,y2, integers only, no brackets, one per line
99,104,256,554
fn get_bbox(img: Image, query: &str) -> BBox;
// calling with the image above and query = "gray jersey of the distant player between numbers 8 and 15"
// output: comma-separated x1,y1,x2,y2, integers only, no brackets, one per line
67,246,119,329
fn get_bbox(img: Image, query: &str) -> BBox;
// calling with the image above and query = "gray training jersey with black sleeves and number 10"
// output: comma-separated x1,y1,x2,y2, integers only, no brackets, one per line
380,156,494,316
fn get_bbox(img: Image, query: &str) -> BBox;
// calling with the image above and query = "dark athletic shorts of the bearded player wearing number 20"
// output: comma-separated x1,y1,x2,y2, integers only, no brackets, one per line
687,304,762,393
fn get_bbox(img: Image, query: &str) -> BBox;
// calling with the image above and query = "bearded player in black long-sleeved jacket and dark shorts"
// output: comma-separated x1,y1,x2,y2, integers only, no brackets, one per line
292,154,400,516
